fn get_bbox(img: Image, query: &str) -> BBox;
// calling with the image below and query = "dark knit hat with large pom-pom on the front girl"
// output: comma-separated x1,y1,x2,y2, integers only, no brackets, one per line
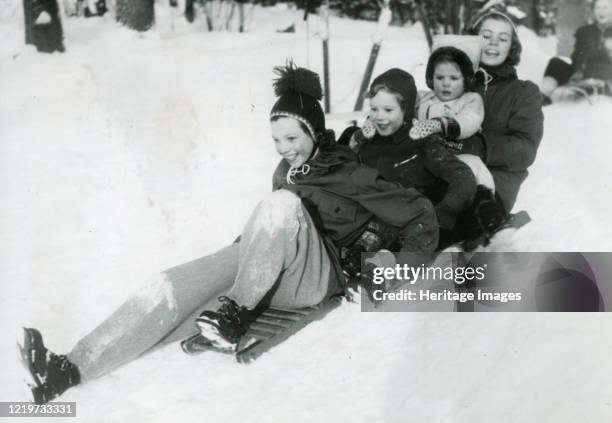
270,62,325,142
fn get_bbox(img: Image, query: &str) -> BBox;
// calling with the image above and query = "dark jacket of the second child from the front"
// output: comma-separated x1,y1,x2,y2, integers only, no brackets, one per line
343,125,476,234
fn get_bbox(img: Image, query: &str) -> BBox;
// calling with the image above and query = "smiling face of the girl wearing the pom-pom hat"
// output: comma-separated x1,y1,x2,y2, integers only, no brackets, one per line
270,117,314,167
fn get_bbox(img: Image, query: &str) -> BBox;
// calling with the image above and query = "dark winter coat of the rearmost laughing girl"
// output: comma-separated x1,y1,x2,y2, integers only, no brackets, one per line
462,64,544,212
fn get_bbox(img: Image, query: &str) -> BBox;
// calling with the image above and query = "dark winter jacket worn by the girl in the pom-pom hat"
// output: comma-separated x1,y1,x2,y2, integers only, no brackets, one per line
273,145,438,258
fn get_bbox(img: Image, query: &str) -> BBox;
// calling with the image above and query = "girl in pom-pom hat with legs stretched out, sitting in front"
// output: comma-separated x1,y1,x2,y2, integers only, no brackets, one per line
20,63,438,403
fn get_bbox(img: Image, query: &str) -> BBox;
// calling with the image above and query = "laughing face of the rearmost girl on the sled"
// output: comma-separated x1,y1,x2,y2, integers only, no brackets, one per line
478,18,513,66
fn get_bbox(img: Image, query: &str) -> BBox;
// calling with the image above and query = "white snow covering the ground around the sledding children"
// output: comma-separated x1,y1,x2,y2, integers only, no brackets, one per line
0,0,612,422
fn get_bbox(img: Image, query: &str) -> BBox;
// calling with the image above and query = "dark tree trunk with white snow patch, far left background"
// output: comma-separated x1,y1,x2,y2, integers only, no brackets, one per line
23,0,65,53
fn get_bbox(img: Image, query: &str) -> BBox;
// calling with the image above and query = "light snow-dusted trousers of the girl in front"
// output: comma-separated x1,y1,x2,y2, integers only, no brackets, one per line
68,190,340,382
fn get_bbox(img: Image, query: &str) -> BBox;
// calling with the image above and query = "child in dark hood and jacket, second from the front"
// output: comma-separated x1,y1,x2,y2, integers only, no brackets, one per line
340,68,476,243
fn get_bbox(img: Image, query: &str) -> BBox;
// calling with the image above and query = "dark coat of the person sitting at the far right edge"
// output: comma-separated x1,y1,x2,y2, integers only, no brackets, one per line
572,24,612,80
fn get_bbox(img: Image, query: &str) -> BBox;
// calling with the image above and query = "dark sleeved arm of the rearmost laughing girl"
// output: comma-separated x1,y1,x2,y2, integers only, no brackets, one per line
483,81,544,171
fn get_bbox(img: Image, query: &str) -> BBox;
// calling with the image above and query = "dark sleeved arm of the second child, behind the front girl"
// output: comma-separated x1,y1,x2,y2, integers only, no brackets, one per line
420,135,476,229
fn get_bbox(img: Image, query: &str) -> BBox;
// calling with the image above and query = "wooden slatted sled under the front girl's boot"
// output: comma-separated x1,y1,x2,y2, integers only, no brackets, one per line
181,295,343,364
